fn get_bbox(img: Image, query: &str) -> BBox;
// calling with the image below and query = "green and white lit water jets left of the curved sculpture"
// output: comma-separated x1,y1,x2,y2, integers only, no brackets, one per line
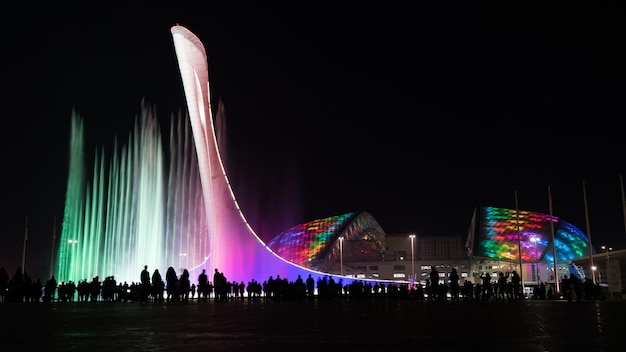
55,106,208,283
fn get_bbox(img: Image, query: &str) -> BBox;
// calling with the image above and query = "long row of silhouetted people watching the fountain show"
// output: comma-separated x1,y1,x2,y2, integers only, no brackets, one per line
0,265,603,304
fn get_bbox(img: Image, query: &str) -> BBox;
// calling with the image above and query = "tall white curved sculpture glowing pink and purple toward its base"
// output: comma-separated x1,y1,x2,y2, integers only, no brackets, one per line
171,25,344,282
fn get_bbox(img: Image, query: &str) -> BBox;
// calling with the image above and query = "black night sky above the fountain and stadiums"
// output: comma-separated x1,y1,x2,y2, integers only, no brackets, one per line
0,1,626,278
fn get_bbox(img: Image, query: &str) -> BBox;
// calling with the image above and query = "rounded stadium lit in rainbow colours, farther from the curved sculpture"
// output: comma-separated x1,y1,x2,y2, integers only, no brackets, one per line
466,207,595,290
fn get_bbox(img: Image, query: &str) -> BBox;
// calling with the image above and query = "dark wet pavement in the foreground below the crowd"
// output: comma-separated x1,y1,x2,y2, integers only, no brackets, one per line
0,299,626,352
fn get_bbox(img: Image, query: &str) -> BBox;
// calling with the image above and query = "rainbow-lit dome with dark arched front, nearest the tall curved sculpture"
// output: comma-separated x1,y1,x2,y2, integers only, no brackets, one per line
267,212,385,273
